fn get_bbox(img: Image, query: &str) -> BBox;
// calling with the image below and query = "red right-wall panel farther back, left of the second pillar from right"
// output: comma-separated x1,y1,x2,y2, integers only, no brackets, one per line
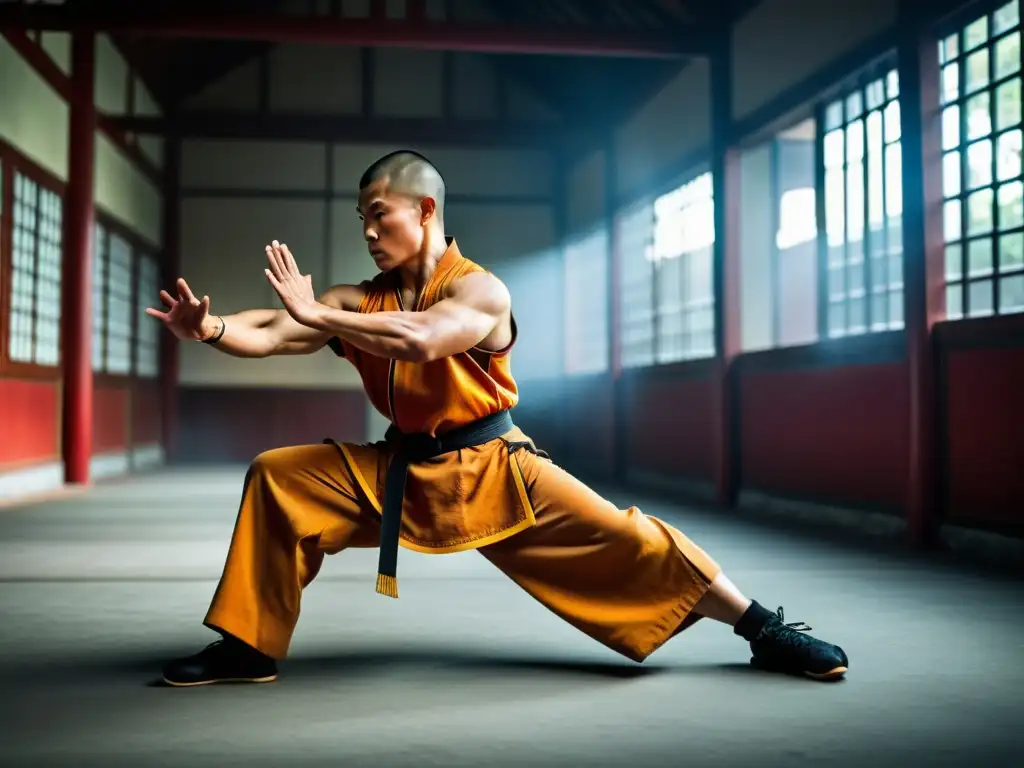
627,372,714,480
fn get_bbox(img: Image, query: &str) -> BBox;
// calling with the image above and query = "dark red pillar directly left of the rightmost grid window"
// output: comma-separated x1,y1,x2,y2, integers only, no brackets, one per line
897,2,945,547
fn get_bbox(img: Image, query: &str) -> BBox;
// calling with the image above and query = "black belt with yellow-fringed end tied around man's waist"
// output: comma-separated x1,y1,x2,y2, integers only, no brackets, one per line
377,411,515,597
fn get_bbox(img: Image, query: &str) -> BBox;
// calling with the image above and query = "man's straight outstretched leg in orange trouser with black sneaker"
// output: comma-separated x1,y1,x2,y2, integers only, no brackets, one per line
480,451,848,679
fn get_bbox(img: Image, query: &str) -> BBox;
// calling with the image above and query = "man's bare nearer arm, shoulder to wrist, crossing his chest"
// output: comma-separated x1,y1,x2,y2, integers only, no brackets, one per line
312,272,511,362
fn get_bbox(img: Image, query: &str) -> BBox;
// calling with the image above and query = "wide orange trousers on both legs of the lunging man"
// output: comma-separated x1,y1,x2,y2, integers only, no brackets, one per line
204,444,720,662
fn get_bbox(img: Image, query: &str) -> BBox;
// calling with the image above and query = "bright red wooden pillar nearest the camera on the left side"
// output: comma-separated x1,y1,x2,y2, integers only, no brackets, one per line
61,32,96,483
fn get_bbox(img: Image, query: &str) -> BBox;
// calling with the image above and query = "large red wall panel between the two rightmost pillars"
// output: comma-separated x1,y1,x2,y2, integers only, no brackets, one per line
739,364,910,509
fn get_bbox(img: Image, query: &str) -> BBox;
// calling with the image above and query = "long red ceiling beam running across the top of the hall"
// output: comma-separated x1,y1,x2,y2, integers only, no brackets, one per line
0,3,708,58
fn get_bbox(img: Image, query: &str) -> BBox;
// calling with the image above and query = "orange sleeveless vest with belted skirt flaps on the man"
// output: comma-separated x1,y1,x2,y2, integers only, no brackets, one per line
332,239,536,554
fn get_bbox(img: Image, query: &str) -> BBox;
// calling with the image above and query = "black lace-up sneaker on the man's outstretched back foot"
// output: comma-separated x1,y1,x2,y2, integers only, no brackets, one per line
751,607,850,680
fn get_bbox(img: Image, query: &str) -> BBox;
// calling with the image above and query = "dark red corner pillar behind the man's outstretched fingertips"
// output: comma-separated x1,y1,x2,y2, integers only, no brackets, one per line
160,135,181,461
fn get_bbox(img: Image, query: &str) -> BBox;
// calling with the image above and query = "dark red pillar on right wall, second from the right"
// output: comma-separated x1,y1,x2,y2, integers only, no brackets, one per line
710,23,740,507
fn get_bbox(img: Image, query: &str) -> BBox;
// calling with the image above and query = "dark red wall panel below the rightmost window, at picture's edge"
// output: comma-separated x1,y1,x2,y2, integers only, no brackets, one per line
947,347,1024,525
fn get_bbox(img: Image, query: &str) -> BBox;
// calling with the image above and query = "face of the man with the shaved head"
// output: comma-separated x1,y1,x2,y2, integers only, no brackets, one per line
358,179,429,272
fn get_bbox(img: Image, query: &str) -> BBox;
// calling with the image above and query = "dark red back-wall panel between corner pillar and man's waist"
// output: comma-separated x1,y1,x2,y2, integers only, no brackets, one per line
173,387,367,462
